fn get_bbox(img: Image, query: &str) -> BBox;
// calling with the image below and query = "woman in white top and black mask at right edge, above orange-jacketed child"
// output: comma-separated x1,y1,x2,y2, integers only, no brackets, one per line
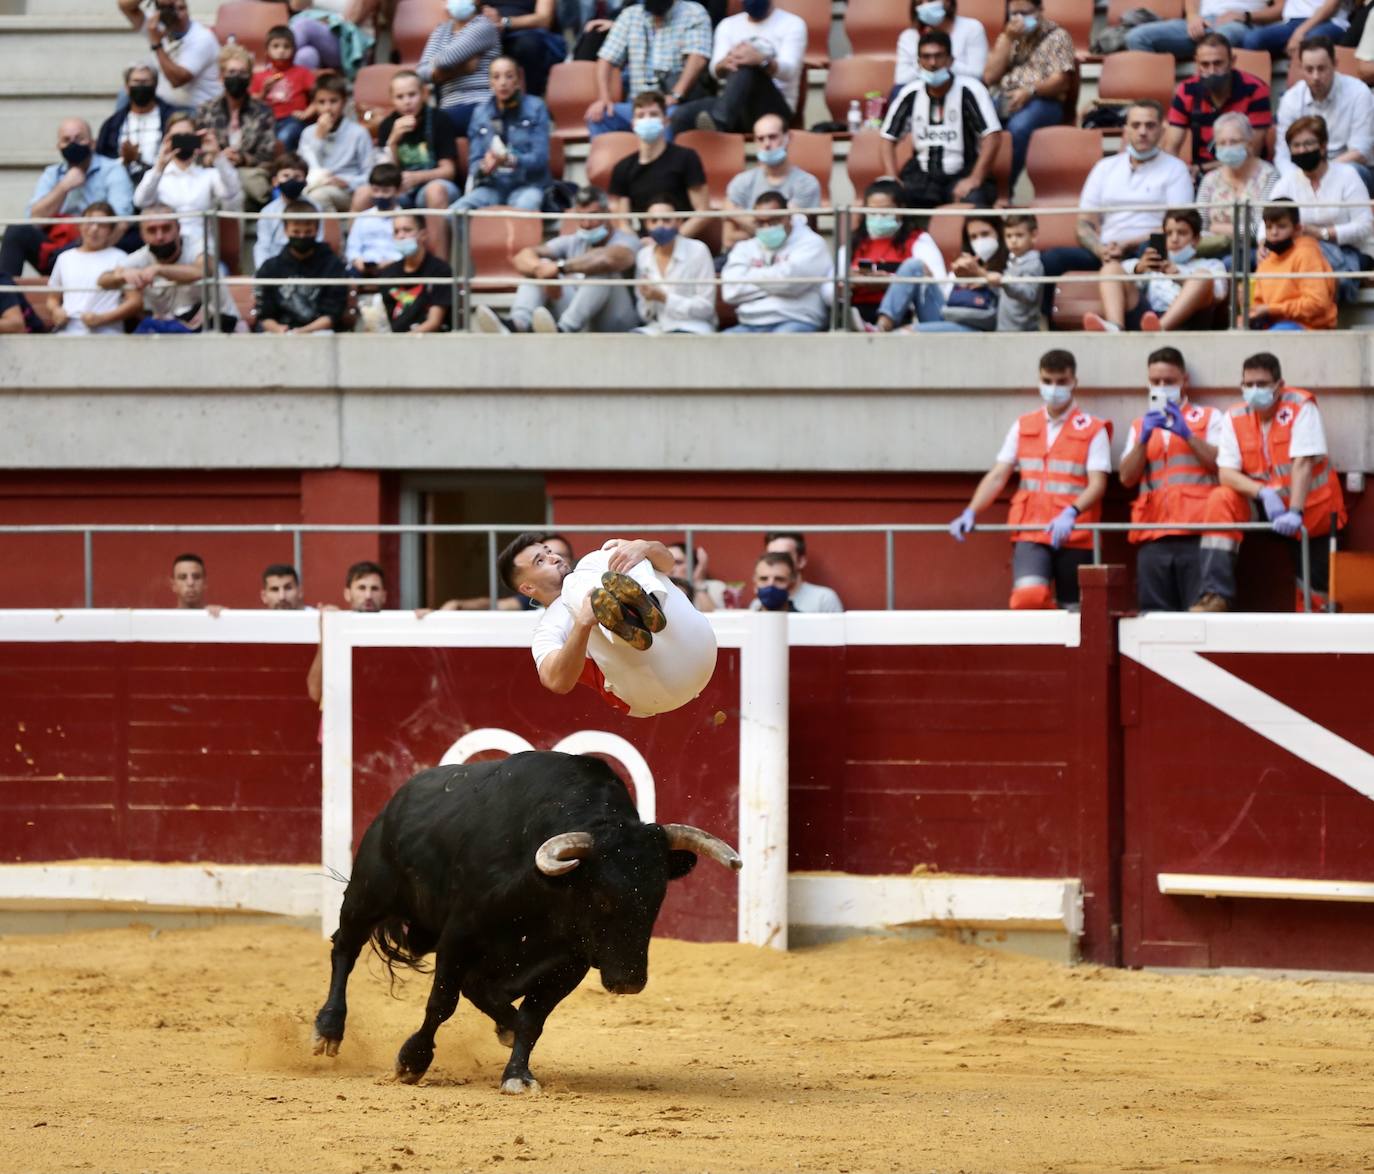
1270,115,1374,294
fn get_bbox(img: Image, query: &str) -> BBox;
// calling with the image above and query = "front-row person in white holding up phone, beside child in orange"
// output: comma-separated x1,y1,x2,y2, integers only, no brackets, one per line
1083,208,1228,334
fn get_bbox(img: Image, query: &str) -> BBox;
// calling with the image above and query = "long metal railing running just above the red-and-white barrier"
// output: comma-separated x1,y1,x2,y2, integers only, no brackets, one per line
0,522,1333,612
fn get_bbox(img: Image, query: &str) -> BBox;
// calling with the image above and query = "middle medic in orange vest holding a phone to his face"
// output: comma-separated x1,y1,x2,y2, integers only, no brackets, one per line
1121,346,1221,612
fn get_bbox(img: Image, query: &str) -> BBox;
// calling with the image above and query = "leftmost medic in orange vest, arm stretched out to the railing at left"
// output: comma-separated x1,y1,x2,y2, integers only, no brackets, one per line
949,351,1112,609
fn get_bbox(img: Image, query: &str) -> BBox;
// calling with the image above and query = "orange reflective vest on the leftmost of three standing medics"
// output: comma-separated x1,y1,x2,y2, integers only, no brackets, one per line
1007,407,1112,550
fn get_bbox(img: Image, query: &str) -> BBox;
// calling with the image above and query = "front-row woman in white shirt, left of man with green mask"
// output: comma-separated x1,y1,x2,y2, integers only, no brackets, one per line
635,195,716,334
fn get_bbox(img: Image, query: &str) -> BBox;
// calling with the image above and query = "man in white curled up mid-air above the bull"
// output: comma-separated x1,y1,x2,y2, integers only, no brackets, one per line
497,533,716,718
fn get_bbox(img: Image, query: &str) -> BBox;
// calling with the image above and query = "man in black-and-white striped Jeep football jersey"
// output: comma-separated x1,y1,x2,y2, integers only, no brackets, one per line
879,28,1000,208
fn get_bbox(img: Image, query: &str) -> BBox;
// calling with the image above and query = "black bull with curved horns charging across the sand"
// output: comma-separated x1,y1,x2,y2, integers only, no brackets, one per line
315,751,741,1093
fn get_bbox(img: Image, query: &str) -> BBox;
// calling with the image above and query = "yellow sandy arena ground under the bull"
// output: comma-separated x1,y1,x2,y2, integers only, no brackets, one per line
0,925,1374,1174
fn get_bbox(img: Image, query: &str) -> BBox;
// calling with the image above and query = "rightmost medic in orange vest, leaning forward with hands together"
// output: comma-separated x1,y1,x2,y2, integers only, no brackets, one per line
1191,353,1345,612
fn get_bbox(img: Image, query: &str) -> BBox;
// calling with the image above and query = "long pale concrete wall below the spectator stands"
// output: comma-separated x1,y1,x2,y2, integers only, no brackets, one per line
0,333,1374,472
